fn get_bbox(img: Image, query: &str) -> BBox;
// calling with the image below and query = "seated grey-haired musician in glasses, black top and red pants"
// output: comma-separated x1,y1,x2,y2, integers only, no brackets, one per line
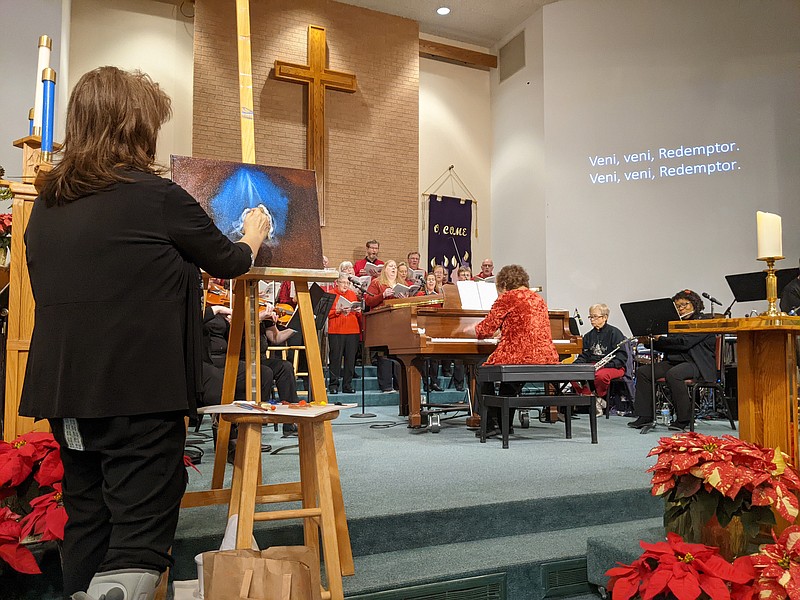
572,304,628,414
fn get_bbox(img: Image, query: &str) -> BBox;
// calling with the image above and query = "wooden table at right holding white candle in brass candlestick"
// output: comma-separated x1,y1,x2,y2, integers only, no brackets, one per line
669,316,800,467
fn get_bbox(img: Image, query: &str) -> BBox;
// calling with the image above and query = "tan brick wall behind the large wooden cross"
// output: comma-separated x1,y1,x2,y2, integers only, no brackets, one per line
192,0,420,266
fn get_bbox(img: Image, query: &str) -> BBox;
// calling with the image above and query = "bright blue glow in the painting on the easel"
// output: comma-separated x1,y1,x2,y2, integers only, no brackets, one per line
209,165,289,246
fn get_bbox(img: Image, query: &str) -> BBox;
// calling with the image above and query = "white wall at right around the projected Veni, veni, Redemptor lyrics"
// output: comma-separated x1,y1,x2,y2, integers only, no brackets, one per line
492,0,800,325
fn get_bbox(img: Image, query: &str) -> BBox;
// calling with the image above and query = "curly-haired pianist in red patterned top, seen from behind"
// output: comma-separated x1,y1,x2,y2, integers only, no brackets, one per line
465,265,558,435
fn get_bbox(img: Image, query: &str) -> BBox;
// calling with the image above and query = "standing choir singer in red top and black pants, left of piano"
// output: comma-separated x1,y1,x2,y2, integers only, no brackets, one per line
328,273,361,394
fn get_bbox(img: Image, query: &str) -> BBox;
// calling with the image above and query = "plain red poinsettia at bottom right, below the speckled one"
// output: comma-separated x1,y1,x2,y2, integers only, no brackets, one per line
606,533,754,600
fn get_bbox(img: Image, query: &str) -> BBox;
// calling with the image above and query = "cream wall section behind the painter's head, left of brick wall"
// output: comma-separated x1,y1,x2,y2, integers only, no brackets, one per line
69,0,193,172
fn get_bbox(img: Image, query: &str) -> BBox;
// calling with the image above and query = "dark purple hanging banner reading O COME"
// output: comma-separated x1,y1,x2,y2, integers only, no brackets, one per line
426,194,472,279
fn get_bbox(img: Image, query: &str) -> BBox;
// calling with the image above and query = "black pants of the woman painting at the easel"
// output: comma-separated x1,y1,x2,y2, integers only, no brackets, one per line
50,412,187,598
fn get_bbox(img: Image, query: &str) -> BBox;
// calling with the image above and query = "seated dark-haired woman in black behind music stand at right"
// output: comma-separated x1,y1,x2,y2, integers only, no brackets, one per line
628,290,716,431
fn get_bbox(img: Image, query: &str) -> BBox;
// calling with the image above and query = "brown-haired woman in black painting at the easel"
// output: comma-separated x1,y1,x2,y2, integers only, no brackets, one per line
19,67,270,600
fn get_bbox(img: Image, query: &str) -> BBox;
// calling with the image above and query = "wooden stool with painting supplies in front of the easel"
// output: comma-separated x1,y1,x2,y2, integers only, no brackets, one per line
221,409,349,600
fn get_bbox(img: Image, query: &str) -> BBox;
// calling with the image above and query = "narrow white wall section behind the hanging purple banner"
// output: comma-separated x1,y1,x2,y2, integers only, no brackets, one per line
419,58,492,269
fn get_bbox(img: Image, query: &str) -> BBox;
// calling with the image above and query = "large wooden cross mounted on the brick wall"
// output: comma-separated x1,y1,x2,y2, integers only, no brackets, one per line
275,25,356,225
